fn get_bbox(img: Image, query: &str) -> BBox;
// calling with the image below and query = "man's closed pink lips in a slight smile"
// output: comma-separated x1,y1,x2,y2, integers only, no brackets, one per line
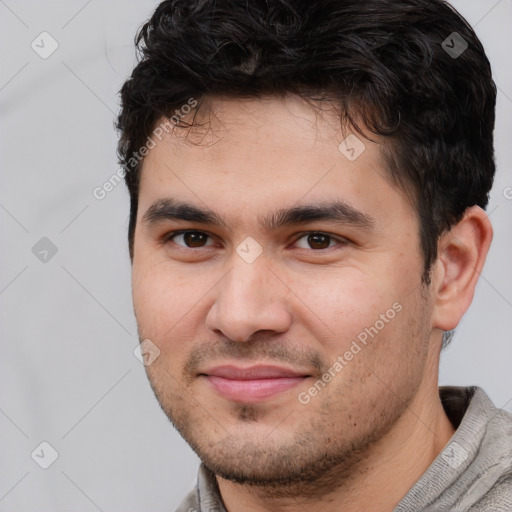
199,365,311,403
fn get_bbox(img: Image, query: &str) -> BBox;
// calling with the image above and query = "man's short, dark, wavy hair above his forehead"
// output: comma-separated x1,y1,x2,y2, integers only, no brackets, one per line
117,0,496,283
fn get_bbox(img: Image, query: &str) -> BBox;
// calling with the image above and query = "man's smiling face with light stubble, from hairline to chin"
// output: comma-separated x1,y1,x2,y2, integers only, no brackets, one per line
133,97,432,485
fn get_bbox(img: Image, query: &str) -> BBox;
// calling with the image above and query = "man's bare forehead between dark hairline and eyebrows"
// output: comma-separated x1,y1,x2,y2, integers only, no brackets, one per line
139,96,411,226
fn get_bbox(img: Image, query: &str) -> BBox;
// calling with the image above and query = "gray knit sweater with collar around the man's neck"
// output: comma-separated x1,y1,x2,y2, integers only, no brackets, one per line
176,387,512,512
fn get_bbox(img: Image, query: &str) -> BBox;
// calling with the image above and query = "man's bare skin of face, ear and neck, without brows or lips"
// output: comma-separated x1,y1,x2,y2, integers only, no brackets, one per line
132,96,492,512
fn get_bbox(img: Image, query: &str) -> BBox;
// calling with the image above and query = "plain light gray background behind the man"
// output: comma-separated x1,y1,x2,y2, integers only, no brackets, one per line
0,0,512,512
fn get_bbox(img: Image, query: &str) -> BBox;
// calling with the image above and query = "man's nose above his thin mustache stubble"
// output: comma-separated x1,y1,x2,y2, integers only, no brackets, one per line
206,255,292,342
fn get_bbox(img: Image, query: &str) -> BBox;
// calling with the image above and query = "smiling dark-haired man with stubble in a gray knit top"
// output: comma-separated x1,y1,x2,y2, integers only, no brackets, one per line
118,0,512,512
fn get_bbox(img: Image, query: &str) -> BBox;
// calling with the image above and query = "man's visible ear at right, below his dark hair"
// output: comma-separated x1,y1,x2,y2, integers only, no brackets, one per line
431,206,492,331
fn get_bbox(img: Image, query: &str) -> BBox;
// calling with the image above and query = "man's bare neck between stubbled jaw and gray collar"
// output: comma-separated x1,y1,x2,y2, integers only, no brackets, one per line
217,374,454,512
